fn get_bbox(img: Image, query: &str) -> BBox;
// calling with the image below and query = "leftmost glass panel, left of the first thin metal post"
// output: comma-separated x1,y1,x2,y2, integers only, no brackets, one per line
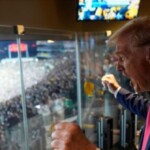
0,26,24,150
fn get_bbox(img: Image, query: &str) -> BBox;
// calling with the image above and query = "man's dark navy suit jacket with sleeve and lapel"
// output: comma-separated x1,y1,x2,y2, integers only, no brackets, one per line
117,88,150,150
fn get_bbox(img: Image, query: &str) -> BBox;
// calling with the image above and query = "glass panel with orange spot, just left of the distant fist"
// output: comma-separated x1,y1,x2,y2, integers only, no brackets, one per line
78,33,107,144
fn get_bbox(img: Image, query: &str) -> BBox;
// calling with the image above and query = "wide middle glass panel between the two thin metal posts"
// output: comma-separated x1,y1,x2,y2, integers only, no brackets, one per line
18,28,77,150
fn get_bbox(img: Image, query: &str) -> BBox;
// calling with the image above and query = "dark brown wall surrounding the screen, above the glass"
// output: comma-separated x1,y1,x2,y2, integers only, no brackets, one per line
0,0,150,31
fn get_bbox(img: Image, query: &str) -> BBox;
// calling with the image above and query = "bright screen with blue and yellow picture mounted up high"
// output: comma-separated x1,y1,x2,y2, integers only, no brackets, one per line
77,0,140,21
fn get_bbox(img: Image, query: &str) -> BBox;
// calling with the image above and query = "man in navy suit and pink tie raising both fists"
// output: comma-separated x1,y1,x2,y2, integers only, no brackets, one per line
52,17,150,150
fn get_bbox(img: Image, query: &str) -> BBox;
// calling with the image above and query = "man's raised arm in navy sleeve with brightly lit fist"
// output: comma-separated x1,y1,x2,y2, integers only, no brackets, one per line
102,74,150,118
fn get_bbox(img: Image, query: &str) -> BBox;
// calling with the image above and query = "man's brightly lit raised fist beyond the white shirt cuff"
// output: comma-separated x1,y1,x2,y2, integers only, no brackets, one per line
102,74,121,94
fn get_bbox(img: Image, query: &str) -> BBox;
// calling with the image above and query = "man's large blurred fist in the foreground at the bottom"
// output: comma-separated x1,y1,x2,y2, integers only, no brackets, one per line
51,122,96,150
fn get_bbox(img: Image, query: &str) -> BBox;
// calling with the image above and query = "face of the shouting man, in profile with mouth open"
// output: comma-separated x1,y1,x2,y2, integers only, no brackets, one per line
115,38,150,92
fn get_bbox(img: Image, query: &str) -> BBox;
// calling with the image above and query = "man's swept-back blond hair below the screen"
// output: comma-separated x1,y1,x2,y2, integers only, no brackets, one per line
108,17,150,46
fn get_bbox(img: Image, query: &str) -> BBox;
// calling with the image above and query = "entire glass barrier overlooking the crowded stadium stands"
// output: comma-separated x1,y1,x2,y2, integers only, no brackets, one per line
0,26,146,150
